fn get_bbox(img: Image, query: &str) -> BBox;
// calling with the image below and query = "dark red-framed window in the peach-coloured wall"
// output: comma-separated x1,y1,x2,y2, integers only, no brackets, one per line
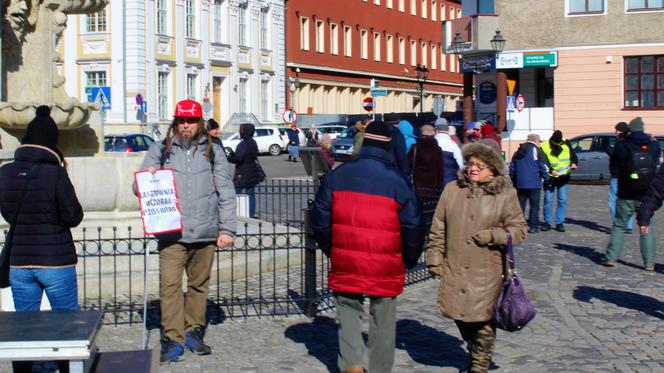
625,56,664,109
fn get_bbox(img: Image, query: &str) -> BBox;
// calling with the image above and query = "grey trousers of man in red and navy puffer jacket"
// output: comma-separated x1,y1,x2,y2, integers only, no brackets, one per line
334,293,397,373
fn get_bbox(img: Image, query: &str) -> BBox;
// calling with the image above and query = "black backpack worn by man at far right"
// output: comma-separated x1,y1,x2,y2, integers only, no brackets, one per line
624,141,657,192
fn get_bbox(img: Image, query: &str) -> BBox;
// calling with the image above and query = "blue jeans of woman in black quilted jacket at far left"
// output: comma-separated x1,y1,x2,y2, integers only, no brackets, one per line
9,267,78,312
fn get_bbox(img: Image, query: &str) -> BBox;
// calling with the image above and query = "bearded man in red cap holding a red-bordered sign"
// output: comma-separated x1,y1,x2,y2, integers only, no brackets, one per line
136,100,237,363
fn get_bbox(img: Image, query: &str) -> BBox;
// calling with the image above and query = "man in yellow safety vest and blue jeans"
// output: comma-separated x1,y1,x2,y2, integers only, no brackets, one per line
540,130,578,232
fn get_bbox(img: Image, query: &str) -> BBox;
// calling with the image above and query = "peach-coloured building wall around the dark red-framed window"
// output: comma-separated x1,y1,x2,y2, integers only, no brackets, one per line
554,45,664,138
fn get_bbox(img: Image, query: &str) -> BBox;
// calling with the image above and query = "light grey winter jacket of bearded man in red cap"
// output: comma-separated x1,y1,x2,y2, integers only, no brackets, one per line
141,136,237,243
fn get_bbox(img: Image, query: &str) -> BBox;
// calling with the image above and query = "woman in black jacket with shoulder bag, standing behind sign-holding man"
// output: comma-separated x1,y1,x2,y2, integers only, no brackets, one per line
228,123,265,218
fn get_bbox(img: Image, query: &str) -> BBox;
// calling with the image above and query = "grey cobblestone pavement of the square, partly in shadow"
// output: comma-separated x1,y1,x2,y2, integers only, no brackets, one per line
0,185,664,373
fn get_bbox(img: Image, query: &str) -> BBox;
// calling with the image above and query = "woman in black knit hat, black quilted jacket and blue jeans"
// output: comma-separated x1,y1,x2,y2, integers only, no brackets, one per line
0,106,83,371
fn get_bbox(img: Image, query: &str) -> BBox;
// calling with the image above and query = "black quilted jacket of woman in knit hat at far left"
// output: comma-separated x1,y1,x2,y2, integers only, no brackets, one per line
0,145,83,267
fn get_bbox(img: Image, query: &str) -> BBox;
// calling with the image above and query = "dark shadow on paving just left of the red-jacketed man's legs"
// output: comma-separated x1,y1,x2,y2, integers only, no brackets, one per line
284,316,339,372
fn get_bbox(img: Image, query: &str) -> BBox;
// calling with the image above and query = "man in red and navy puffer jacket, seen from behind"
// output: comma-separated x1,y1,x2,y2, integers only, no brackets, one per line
312,122,424,373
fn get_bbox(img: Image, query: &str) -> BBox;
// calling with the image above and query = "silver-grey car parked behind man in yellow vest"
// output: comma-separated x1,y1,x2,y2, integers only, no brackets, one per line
569,132,664,180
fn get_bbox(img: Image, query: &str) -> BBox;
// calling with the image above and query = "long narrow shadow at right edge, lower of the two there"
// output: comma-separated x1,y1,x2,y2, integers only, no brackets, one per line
574,286,664,320
